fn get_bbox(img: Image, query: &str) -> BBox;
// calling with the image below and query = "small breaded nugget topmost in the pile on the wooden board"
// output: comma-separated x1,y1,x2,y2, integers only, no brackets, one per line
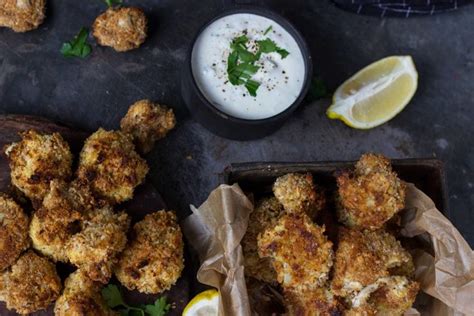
120,100,176,154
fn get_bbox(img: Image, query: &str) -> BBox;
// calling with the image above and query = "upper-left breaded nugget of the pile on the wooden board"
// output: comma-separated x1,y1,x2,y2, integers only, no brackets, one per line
5,130,72,205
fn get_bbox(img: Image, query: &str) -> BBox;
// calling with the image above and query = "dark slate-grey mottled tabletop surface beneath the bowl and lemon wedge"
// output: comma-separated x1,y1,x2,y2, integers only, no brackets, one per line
0,0,474,245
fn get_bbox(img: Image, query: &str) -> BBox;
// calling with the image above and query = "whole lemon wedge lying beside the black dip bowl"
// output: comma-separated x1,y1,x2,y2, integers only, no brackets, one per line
326,56,418,129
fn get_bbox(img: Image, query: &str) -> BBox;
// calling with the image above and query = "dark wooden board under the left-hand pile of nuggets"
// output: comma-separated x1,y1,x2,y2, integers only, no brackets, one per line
0,115,189,316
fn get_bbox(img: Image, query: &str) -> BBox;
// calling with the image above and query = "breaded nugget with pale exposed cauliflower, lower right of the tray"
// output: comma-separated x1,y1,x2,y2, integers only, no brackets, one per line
351,276,420,316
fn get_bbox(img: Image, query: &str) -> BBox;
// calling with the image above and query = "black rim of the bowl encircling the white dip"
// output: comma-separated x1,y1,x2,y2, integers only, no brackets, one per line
186,5,313,125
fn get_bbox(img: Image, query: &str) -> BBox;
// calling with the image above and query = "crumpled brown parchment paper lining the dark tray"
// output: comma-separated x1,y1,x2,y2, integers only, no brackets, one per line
183,184,474,316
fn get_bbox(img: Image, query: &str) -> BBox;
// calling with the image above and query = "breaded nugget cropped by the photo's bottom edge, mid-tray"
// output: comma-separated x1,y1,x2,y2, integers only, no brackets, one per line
284,287,344,316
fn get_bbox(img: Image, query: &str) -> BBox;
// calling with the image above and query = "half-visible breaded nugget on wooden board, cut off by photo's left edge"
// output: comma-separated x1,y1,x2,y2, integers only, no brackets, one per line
0,194,30,271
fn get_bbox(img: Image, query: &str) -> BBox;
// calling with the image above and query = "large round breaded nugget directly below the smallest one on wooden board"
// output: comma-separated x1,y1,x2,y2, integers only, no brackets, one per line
77,128,148,203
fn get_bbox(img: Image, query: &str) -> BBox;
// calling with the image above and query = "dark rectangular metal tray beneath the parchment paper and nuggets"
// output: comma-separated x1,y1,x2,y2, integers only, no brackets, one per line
221,159,449,218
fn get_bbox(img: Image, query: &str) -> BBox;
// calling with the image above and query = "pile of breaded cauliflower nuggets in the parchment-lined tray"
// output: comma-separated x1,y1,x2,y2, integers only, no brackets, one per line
242,154,419,316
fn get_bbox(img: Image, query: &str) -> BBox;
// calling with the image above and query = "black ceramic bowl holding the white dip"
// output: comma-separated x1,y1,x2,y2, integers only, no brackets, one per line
181,6,313,140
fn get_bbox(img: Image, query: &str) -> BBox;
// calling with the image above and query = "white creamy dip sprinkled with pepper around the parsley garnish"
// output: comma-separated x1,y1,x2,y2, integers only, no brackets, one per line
192,13,305,120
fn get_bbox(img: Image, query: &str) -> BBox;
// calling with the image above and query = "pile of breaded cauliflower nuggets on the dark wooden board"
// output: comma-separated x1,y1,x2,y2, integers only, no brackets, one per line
0,100,184,315
